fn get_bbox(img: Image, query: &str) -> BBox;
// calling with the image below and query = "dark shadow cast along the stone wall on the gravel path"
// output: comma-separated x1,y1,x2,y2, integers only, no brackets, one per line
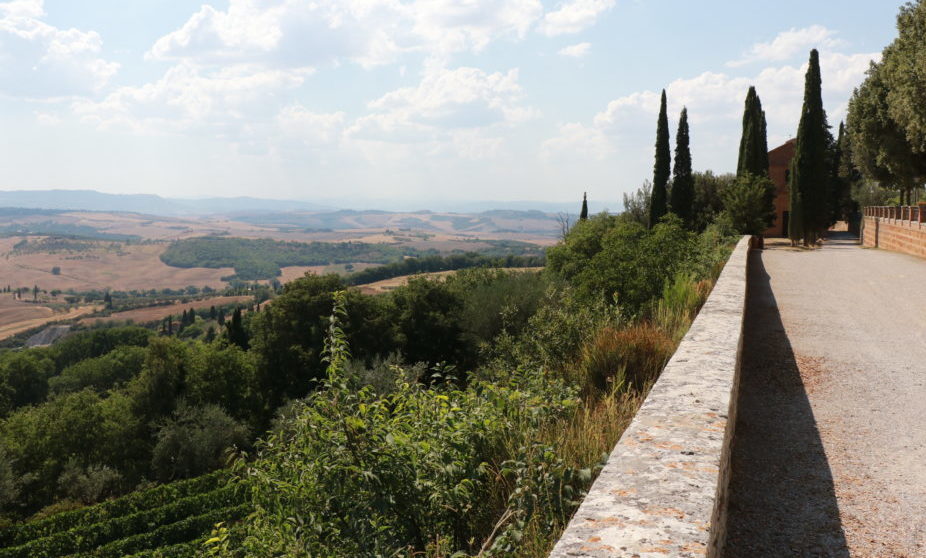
724,251,849,558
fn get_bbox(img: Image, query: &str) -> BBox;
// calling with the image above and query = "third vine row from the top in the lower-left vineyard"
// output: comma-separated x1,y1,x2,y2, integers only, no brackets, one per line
71,504,251,558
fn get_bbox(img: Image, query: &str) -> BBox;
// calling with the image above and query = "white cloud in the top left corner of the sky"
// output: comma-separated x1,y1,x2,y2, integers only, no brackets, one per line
0,0,119,99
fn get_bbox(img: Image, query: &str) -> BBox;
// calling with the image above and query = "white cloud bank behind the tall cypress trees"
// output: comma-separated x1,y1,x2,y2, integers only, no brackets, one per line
539,46,879,186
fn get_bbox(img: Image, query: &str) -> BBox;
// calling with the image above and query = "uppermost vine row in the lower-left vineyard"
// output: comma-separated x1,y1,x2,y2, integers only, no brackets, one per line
0,471,231,547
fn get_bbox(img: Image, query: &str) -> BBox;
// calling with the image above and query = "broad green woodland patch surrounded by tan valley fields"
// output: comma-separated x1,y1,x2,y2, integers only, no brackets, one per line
161,236,417,281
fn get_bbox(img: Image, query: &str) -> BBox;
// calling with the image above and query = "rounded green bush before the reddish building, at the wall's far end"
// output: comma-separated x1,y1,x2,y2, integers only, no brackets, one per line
722,173,775,235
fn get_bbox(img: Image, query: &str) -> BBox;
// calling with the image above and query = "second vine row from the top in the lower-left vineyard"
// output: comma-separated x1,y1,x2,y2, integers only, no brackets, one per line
0,485,243,558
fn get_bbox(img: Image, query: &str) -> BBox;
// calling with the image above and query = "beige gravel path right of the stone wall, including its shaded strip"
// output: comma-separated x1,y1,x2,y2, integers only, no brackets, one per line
726,235,926,557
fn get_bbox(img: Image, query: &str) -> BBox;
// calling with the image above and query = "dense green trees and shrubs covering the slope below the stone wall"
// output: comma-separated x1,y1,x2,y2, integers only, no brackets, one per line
0,209,740,555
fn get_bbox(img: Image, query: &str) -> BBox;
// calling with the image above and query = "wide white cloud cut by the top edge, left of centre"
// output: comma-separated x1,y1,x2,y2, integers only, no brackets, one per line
148,0,543,67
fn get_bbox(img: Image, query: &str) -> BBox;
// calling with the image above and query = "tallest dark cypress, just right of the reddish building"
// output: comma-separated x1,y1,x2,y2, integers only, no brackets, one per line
788,49,832,245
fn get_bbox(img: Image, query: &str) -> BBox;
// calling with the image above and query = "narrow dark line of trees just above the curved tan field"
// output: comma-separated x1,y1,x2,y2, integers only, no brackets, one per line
345,252,546,285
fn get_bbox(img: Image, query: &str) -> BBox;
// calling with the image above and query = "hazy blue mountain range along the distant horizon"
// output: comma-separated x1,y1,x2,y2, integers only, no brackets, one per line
0,190,620,217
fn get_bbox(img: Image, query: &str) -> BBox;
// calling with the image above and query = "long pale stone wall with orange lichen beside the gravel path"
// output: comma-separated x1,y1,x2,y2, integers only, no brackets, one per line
550,237,749,558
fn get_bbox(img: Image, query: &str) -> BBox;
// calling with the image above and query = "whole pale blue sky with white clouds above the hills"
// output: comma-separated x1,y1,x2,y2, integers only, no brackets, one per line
0,0,901,208
